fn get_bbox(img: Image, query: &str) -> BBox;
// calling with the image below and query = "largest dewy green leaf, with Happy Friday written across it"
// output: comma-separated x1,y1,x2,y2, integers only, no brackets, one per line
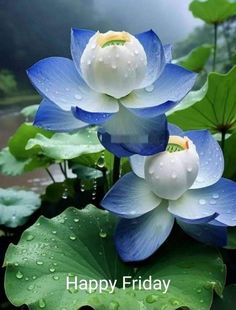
4,206,225,310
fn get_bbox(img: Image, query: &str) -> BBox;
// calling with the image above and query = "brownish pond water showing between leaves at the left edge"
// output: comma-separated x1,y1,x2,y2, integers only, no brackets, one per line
0,102,63,192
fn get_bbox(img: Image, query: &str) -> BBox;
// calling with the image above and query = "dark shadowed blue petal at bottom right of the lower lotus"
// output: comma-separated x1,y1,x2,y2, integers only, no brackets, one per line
177,220,227,247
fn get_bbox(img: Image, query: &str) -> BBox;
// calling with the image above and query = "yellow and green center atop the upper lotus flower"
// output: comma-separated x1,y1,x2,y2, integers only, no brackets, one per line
97,31,130,48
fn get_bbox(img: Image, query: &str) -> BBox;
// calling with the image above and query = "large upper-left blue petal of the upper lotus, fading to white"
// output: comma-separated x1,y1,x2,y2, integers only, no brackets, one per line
27,57,119,113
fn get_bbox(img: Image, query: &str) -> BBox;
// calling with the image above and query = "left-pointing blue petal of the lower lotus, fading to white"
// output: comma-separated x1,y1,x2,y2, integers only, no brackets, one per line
101,172,161,218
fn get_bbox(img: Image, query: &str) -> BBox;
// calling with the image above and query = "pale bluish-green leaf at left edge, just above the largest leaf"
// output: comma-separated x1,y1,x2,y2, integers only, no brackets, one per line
0,188,40,228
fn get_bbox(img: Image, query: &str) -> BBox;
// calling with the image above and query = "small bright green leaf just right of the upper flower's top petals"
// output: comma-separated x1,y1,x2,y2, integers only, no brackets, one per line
175,44,212,72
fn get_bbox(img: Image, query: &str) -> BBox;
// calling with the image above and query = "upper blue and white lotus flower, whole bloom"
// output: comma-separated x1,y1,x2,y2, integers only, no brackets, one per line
27,29,196,157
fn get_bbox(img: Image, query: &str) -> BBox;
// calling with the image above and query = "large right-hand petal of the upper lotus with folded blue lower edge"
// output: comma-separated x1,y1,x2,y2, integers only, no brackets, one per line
121,64,196,117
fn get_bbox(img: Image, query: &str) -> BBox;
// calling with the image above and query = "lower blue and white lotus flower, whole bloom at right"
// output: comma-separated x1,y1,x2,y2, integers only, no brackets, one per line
102,126,236,261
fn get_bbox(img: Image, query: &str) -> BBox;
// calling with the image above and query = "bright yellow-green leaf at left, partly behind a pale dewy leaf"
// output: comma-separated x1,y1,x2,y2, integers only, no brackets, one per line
8,123,53,159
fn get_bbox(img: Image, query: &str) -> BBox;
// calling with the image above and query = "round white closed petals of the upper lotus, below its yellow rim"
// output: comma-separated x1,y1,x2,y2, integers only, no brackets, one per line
80,32,147,98
